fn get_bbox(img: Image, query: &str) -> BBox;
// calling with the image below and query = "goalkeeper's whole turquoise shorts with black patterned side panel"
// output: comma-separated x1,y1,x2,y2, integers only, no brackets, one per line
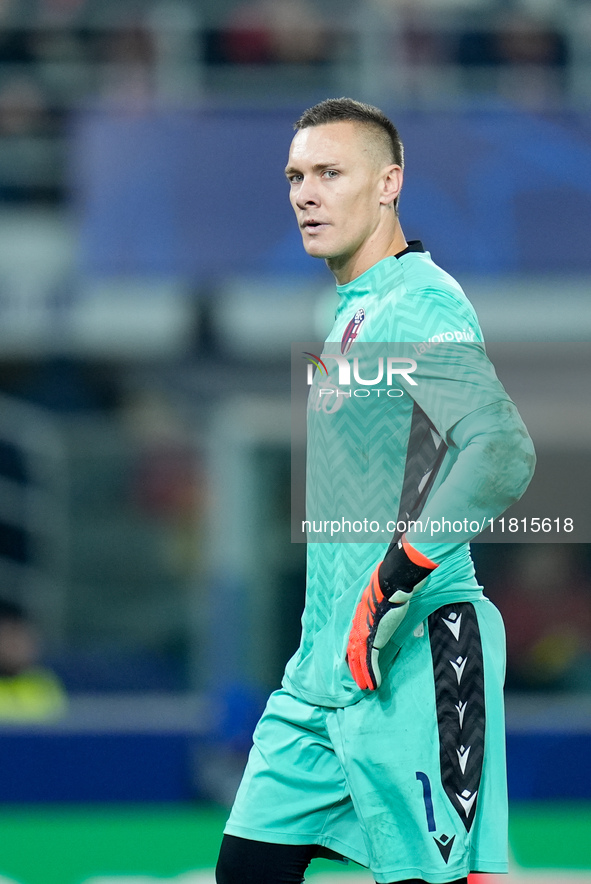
225,598,507,884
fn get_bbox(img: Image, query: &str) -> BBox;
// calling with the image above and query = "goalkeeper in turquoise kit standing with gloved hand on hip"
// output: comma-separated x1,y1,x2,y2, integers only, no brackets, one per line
216,99,535,884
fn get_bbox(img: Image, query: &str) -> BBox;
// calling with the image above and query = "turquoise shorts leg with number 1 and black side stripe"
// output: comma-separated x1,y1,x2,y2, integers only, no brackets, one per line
327,600,507,882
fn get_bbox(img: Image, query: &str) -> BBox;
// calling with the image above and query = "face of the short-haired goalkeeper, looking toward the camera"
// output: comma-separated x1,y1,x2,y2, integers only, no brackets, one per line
285,121,394,263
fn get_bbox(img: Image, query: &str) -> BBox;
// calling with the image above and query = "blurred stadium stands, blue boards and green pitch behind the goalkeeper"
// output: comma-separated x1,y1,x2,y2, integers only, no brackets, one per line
0,0,591,884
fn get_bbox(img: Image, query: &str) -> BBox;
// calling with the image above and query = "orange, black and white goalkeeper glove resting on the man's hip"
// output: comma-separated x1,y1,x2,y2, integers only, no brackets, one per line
347,540,437,691
